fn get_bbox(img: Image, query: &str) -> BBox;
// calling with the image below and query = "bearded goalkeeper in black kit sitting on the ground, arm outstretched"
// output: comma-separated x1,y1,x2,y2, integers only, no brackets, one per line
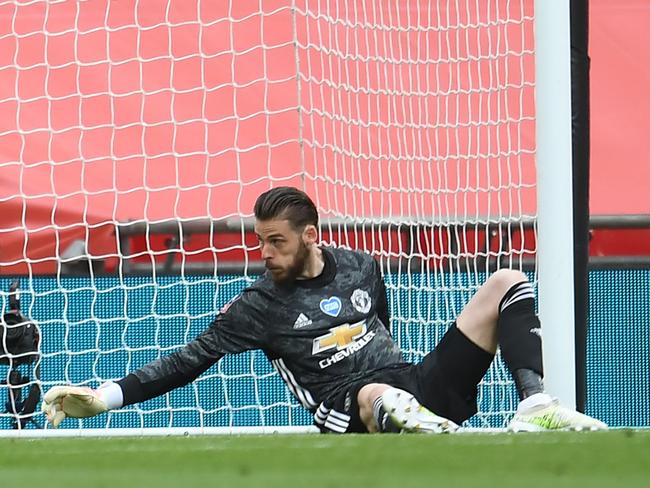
43,187,606,433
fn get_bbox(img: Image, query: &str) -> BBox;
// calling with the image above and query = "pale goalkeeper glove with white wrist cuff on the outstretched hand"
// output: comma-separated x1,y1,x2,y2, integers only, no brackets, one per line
41,383,121,428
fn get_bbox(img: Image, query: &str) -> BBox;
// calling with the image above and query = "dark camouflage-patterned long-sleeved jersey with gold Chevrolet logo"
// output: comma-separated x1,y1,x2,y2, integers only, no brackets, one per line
118,248,403,412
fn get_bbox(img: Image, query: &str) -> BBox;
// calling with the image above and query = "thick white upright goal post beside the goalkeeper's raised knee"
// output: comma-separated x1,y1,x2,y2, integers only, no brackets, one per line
535,0,576,407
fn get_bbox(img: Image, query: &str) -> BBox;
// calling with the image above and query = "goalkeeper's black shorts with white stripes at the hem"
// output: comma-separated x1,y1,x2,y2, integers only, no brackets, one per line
314,324,494,433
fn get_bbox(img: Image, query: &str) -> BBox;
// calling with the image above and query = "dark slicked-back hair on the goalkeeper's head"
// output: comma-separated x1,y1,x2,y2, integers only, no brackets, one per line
254,186,318,229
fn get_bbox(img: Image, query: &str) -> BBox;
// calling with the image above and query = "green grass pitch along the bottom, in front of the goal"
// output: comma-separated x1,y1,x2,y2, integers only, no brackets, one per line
0,430,650,488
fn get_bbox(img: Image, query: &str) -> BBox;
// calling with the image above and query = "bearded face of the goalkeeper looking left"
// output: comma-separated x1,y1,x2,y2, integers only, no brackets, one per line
255,219,311,283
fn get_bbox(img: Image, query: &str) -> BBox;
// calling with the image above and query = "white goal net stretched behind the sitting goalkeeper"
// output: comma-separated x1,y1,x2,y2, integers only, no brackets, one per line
0,0,536,432
